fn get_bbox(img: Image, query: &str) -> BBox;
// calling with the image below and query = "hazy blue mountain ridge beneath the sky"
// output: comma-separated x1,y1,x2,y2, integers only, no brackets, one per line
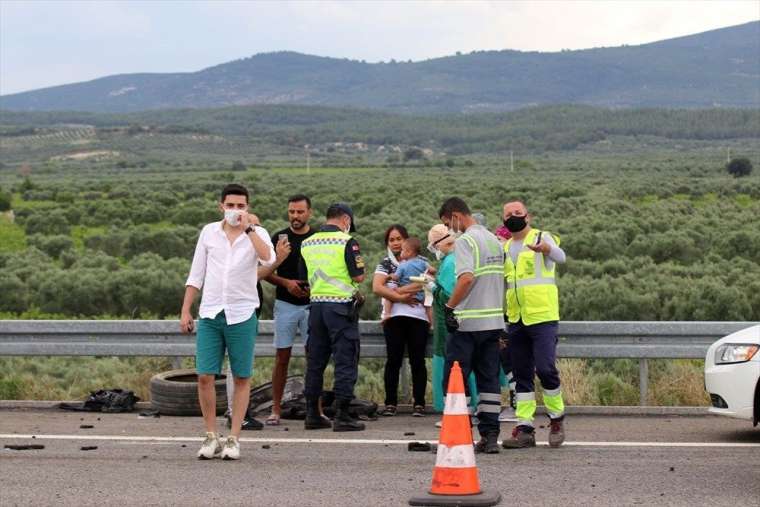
0,21,760,113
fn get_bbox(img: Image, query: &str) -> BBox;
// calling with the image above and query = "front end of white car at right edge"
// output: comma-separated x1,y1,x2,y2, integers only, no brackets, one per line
705,325,760,426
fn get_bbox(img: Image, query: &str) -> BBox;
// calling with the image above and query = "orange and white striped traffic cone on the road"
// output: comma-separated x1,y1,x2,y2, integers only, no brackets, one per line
409,361,501,506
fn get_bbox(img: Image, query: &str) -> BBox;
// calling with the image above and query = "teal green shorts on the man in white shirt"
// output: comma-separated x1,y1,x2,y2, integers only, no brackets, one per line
195,312,258,378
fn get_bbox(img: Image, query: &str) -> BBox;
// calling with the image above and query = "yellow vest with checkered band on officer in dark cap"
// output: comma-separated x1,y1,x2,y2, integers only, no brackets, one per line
301,231,356,303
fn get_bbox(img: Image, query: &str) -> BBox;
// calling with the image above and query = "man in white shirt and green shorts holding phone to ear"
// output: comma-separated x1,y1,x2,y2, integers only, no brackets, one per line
180,184,275,459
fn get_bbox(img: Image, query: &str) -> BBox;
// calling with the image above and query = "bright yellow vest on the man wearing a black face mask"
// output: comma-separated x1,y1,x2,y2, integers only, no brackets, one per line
504,229,559,326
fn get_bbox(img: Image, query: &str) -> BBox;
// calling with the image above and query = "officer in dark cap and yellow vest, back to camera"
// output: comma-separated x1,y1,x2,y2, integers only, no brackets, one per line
301,203,364,431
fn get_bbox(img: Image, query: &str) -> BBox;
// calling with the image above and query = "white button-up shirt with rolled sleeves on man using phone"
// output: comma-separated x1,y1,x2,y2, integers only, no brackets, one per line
185,222,275,324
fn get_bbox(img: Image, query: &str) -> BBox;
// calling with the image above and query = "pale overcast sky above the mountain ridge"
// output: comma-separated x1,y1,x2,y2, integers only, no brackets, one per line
0,0,760,94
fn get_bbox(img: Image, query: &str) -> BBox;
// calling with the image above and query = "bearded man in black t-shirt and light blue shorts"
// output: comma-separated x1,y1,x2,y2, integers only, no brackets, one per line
266,194,316,426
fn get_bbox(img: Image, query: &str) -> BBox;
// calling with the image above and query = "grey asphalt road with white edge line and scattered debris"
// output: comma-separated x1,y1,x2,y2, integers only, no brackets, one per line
0,409,760,507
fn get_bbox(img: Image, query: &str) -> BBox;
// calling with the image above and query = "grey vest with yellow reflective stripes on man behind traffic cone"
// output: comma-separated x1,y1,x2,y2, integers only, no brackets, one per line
454,233,504,322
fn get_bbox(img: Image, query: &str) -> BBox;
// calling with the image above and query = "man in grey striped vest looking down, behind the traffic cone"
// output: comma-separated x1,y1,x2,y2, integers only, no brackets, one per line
438,197,504,454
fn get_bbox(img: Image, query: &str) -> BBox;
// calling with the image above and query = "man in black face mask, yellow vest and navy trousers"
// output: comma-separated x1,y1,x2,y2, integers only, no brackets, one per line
502,201,565,449
